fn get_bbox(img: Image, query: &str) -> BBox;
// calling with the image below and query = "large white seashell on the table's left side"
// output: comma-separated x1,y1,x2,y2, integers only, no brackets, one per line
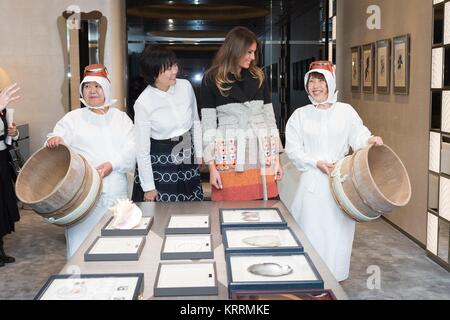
110,199,142,230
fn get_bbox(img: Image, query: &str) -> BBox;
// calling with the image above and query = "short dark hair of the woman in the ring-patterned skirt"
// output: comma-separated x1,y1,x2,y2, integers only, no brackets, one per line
139,45,178,87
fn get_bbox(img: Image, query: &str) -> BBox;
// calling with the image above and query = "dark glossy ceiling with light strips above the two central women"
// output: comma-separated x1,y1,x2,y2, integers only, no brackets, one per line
127,0,322,45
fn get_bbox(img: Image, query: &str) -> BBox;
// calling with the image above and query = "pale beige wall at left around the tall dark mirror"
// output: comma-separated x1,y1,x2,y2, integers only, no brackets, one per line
0,0,126,151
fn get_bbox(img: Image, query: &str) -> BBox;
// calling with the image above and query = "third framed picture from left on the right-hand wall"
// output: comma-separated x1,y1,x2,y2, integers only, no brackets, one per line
376,39,391,94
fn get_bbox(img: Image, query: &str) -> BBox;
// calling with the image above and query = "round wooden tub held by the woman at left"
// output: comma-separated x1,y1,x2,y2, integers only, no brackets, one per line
16,145,101,226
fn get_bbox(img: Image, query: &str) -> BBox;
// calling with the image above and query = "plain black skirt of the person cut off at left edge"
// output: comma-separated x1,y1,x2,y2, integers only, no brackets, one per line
0,150,20,238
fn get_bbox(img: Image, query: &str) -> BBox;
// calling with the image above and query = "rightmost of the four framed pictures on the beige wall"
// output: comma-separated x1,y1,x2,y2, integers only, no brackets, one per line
393,34,410,95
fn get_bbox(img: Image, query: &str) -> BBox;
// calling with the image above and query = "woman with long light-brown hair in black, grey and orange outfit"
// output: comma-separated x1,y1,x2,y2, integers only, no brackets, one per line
201,27,283,201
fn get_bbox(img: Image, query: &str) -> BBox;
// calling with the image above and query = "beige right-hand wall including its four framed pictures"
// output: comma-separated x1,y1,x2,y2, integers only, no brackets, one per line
336,0,432,254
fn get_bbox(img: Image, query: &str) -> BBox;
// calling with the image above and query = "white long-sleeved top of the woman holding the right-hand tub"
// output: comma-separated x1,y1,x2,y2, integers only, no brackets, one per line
285,102,371,172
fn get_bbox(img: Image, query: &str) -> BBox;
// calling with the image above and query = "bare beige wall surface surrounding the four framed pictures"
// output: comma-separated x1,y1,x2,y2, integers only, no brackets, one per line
337,0,432,244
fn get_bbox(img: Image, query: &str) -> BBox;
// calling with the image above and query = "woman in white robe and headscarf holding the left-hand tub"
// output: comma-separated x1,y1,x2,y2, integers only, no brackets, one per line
46,65,136,258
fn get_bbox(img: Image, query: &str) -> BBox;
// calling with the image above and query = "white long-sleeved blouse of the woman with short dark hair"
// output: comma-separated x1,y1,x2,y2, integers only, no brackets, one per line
134,79,202,192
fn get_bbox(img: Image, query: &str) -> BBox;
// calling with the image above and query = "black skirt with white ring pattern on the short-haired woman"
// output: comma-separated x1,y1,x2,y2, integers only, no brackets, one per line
132,132,203,202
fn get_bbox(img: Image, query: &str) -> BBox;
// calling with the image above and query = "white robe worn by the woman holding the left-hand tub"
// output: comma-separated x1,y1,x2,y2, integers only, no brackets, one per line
49,107,136,258
